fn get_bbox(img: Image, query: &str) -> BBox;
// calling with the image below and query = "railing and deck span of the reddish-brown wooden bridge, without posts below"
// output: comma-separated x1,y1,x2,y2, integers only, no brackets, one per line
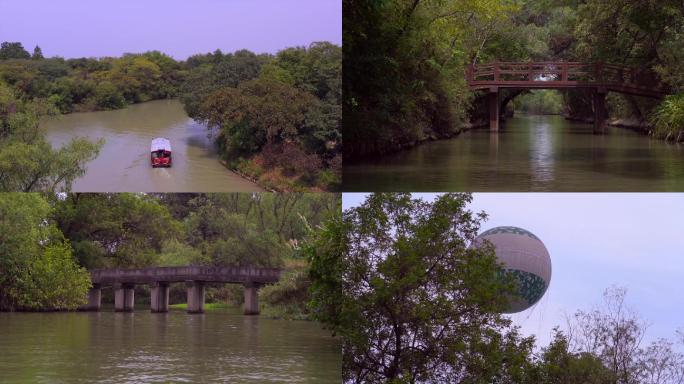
466,62,667,97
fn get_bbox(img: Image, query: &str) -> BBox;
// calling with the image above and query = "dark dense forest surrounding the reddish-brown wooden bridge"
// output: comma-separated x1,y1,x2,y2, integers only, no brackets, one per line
343,0,684,159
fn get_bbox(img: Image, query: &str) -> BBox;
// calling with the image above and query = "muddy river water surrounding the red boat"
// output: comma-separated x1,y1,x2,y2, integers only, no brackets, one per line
41,100,261,192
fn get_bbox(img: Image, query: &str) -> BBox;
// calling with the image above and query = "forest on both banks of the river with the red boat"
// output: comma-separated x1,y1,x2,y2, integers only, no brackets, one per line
0,42,342,192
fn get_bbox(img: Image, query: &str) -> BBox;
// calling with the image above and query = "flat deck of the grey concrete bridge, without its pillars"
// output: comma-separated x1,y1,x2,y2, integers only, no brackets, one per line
90,266,281,285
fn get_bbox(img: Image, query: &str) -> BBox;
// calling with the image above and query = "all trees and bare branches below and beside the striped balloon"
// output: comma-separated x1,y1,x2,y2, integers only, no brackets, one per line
305,193,684,384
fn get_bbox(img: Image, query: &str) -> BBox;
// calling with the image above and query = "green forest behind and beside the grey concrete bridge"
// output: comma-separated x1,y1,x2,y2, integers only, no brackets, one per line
0,193,340,318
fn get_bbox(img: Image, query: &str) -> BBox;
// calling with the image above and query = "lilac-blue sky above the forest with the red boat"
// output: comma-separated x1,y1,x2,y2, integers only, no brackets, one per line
0,0,342,59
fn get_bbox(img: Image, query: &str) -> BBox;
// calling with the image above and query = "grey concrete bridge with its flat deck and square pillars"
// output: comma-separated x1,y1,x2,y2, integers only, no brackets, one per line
81,266,280,315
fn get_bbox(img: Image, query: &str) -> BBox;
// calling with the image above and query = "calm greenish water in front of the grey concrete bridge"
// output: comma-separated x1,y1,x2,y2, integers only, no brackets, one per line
0,309,342,383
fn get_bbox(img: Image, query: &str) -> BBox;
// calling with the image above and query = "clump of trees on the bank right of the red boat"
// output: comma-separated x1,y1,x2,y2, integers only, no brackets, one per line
180,43,342,190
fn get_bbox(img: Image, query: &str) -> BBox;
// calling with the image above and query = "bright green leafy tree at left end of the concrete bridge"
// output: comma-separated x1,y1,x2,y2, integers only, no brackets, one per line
0,193,90,310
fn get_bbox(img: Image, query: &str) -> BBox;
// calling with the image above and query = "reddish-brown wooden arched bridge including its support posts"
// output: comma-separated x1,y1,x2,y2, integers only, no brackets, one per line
466,62,667,131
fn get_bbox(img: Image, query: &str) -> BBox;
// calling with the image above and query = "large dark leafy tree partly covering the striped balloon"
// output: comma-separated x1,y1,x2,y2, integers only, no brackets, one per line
304,193,533,383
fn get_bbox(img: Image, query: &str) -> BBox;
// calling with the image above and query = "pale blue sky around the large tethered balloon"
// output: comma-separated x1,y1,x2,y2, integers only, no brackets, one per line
342,193,684,345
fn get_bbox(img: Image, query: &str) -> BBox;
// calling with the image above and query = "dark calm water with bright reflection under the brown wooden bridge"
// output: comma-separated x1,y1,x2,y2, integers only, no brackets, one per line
343,116,684,192
